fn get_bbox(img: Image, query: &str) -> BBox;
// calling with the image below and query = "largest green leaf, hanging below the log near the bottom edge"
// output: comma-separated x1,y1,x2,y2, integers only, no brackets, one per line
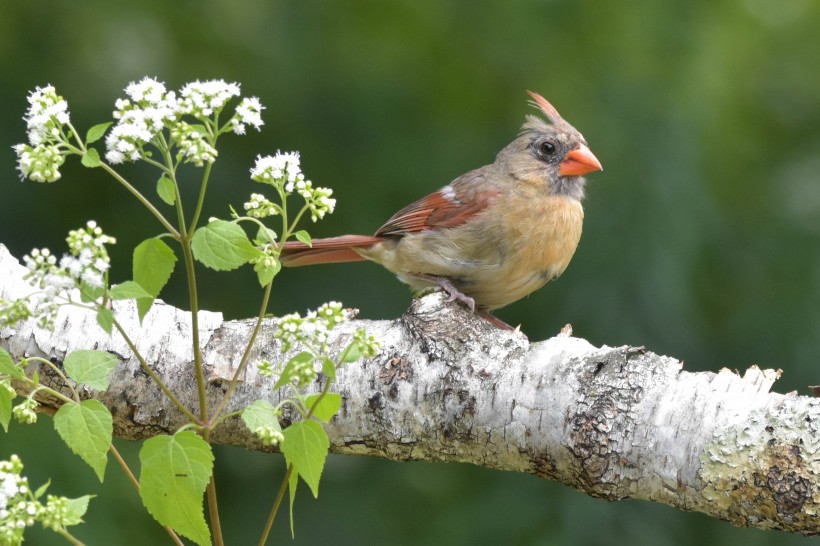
140,430,214,546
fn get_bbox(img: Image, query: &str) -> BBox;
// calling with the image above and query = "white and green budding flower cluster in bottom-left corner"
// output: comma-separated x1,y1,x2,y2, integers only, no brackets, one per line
0,455,80,546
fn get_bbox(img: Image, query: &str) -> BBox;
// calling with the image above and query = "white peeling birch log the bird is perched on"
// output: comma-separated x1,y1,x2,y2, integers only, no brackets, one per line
0,246,820,534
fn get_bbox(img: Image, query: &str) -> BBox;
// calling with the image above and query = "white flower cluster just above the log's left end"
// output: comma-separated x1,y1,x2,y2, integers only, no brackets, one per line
23,220,117,327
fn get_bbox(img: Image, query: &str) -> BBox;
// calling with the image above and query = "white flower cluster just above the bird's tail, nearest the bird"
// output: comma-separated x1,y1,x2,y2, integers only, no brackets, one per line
251,152,336,222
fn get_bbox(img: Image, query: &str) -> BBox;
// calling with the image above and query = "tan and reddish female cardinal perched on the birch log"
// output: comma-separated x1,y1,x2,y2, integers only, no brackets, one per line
281,91,602,328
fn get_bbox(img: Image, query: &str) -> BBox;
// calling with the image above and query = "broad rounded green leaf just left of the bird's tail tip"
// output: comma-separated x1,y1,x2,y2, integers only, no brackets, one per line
191,220,259,271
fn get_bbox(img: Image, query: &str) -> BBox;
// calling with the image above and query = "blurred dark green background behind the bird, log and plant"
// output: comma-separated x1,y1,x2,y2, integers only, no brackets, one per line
0,0,820,545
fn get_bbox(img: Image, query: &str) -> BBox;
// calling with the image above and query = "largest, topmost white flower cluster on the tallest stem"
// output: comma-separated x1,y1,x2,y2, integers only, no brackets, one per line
105,78,264,167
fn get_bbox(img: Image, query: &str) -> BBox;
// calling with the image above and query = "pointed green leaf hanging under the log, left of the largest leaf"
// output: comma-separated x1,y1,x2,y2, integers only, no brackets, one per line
54,400,114,482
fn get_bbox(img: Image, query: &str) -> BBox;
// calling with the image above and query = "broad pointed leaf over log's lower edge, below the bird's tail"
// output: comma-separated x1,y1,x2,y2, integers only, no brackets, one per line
281,420,330,497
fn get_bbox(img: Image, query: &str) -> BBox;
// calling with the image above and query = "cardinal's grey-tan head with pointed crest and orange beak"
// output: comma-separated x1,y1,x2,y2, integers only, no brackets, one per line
496,91,603,200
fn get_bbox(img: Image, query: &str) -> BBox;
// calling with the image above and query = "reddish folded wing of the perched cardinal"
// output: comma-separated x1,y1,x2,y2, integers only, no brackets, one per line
376,169,499,236
